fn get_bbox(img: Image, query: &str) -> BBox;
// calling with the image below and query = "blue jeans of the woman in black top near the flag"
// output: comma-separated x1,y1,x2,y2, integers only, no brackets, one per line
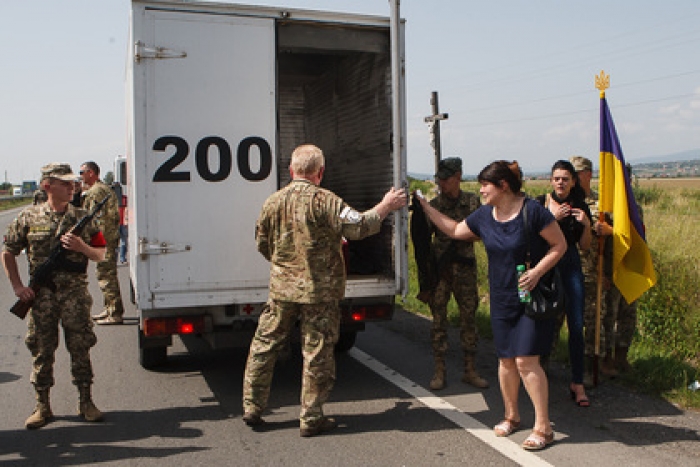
557,245,586,384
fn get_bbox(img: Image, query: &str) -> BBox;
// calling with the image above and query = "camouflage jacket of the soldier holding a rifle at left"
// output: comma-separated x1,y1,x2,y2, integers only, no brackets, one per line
4,203,100,283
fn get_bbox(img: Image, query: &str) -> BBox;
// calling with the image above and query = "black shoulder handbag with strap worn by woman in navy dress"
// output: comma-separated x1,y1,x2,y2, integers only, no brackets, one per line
523,200,565,320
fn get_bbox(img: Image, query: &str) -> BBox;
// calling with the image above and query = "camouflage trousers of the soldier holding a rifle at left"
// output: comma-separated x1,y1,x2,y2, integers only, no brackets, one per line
25,283,97,390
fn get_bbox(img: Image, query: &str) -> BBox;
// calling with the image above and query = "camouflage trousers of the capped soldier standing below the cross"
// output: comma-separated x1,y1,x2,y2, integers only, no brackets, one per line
429,263,479,358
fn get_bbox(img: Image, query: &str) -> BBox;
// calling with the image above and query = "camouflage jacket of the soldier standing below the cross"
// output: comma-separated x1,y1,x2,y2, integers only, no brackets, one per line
430,190,481,261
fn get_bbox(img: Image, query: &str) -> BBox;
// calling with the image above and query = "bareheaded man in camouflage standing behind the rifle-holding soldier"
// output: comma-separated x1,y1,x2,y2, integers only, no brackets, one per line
80,162,124,324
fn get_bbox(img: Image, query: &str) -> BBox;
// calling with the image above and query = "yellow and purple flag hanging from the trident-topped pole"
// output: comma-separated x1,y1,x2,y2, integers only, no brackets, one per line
598,93,656,303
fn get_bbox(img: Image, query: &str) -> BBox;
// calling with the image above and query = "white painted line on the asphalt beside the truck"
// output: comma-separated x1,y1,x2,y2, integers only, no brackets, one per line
348,347,552,467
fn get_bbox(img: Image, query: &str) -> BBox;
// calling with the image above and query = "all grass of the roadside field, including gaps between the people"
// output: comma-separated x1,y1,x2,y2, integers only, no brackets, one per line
399,177,700,408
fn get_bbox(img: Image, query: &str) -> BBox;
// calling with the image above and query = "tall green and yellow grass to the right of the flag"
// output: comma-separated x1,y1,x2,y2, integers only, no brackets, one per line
631,184,700,407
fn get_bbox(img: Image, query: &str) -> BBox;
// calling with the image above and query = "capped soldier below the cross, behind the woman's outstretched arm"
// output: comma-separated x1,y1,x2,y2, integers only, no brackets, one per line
428,157,489,390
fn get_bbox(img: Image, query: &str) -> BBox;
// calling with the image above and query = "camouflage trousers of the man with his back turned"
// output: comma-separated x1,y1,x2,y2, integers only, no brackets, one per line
243,300,340,428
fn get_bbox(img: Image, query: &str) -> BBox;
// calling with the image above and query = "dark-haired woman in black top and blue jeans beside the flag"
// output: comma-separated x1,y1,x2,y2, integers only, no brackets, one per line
537,160,592,407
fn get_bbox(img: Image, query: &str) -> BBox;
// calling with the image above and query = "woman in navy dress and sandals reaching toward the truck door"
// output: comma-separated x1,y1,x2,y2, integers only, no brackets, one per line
421,161,566,450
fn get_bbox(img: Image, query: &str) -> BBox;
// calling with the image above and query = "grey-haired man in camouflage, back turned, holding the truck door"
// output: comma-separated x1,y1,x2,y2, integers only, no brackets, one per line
243,145,407,437
